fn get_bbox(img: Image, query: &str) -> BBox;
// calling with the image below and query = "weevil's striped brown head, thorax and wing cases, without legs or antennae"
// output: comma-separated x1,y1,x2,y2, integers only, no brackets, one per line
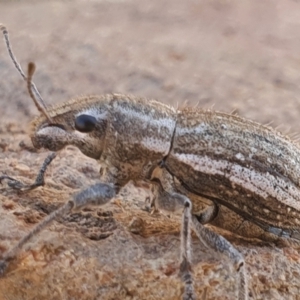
31,94,300,239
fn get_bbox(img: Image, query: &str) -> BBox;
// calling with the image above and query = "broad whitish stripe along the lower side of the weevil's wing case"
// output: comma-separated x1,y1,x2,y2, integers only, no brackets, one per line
175,154,300,210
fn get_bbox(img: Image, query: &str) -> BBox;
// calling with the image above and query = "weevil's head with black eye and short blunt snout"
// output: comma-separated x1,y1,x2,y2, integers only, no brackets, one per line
30,95,110,159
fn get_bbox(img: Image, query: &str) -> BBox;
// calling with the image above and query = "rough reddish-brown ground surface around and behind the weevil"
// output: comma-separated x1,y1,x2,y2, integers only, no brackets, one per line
0,0,300,300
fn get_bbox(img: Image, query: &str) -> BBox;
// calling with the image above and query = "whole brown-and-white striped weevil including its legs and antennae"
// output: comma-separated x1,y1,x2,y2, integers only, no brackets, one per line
0,25,300,300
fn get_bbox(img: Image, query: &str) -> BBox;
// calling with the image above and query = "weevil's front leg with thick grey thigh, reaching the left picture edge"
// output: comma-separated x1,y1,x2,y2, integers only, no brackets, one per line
0,183,119,276
